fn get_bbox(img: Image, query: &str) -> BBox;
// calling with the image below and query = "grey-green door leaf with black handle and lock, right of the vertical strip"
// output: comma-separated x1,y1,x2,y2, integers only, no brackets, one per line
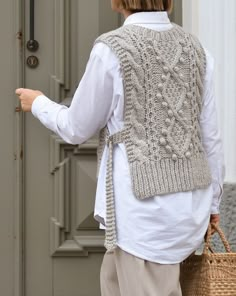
25,0,120,296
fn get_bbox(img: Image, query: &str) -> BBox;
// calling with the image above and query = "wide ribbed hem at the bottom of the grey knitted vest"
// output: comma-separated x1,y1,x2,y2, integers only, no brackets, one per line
130,153,212,199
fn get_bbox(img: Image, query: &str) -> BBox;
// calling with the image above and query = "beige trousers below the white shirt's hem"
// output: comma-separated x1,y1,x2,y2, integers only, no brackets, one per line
101,248,182,296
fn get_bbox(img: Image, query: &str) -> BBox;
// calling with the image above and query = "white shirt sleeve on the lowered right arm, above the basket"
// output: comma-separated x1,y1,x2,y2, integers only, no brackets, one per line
200,49,225,214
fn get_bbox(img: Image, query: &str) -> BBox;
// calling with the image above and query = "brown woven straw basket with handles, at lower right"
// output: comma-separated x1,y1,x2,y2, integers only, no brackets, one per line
180,224,236,296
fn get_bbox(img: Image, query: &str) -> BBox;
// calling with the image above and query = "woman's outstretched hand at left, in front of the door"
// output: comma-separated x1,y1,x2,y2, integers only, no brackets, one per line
16,88,43,112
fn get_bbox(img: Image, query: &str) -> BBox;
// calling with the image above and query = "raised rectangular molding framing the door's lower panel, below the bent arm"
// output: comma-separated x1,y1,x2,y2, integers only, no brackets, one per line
50,135,105,257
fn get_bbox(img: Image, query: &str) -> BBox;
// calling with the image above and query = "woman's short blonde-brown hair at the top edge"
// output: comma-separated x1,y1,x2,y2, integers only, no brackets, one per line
120,0,173,13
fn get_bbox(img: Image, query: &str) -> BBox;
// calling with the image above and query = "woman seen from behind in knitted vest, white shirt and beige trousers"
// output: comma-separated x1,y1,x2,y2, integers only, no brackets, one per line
16,0,224,296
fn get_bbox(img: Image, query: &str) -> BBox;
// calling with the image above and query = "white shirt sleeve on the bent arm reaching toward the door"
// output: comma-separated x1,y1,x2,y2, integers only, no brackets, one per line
32,43,120,144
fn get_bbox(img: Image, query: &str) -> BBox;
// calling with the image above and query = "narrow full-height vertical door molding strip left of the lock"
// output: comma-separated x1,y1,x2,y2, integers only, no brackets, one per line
12,0,25,296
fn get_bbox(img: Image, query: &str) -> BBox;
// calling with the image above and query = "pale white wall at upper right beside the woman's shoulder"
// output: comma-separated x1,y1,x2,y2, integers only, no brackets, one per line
183,0,236,183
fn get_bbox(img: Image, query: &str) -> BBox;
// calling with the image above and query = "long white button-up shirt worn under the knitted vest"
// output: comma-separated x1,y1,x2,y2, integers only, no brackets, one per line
32,12,225,264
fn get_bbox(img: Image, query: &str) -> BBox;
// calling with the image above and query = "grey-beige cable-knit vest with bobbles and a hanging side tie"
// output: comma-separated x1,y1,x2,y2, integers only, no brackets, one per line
96,24,212,249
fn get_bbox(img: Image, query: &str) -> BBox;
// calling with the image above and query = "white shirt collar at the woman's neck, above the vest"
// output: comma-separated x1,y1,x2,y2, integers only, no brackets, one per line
124,11,170,26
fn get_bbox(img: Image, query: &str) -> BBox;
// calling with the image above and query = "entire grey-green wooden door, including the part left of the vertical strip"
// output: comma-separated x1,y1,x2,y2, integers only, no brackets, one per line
0,0,181,296
